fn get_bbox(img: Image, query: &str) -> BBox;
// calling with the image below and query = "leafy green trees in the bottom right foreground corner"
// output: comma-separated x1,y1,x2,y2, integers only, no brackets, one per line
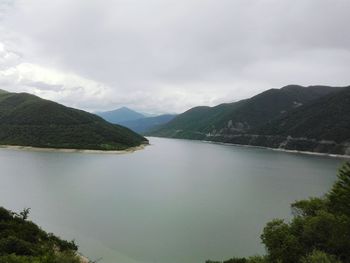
207,162,350,263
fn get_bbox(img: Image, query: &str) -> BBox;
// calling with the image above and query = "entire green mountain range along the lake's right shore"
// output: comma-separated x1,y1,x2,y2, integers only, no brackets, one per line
146,85,350,154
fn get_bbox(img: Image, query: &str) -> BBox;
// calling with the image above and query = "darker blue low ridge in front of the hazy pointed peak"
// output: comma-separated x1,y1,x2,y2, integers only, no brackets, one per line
119,114,176,134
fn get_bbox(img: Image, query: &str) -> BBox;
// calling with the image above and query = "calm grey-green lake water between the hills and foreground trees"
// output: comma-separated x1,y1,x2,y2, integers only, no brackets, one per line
0,138,342,263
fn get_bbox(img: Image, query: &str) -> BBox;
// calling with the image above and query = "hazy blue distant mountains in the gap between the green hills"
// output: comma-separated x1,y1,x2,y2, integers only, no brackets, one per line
96,107,176,134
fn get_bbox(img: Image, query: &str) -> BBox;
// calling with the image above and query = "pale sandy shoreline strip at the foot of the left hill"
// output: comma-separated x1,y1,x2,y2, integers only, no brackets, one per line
0,144,147,154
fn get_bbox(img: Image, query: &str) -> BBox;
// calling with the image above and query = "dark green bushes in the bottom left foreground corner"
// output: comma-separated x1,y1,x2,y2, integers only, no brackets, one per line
0,207,81,263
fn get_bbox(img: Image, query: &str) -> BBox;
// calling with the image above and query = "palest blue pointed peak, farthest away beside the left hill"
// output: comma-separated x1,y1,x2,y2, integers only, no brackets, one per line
96,107,145,124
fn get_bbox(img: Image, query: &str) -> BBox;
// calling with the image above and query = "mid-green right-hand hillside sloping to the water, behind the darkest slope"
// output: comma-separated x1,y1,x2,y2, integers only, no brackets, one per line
150,85,340,139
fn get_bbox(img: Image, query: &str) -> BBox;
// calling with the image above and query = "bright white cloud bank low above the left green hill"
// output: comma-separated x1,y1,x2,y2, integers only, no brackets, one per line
0,43,110,109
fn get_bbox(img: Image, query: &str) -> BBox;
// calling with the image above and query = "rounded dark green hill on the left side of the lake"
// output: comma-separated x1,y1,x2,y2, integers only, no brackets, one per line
0,92,147,150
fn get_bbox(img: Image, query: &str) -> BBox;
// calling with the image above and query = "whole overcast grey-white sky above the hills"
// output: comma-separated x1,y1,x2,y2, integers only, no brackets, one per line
0,0,350,113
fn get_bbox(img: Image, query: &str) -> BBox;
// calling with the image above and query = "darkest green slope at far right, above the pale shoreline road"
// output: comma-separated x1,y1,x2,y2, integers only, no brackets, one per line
256,87,350,143
